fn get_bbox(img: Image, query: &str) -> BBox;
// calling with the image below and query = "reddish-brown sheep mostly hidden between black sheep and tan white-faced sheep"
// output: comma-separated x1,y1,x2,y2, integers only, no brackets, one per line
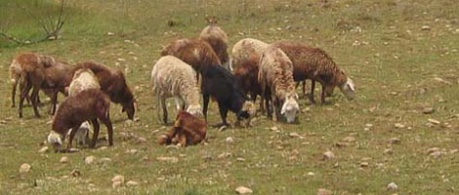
234,54,264,112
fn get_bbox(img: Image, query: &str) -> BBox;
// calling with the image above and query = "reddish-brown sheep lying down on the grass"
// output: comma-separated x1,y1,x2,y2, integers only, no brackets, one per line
158,111,207,147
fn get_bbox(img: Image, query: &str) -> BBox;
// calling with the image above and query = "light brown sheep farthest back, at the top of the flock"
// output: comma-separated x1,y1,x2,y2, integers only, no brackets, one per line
199,17,231,70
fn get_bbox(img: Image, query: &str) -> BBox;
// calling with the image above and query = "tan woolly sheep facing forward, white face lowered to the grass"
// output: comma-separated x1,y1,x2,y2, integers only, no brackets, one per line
258,46,299,123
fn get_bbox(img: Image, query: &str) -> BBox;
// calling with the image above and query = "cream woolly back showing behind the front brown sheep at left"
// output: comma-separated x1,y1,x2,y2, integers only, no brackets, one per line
69,68,100,96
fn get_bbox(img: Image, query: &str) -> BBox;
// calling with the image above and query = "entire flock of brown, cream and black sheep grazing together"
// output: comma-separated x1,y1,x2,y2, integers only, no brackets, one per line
10,18,355,151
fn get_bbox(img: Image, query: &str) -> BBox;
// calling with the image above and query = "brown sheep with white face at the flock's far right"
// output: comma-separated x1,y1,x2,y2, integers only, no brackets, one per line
273,41,355,103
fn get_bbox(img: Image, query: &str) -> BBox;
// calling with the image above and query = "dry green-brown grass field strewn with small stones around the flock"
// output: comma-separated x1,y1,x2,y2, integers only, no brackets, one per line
0,0,459,194
